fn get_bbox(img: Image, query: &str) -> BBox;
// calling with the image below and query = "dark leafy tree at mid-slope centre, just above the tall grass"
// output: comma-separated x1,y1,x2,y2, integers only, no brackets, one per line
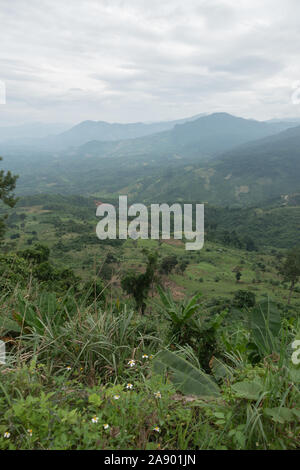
121,253,157,314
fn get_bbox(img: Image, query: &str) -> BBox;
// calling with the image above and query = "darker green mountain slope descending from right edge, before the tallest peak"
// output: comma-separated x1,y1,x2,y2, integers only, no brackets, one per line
132,126,300,205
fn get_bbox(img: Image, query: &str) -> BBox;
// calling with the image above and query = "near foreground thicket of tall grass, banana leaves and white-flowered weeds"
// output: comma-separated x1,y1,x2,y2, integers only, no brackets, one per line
0,276,300,450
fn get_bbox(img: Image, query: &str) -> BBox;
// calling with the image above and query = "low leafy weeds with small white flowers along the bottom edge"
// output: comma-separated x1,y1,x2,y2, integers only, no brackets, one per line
0,334,300,450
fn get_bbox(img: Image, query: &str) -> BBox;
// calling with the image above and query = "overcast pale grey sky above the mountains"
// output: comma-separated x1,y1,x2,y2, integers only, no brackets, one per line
0,0,300,125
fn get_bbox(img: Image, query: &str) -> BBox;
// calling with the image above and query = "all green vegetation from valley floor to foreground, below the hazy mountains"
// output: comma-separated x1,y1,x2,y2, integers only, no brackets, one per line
0,146,300,450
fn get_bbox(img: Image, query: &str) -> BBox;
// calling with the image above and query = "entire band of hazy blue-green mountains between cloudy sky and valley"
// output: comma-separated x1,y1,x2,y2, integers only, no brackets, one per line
0,113,300,205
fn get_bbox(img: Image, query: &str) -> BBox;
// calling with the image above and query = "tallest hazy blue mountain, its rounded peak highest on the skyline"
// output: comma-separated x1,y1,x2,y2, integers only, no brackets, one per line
77,113,292,158
